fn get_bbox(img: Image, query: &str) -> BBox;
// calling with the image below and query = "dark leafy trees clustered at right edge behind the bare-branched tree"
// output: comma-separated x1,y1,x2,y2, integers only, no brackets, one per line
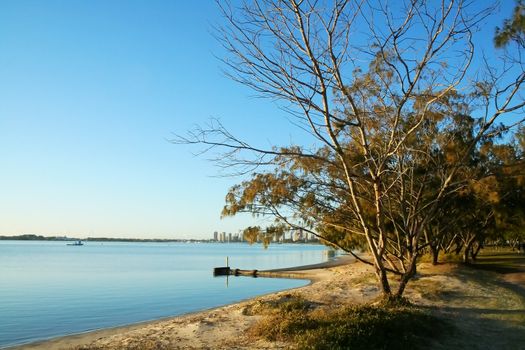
426,126,525,263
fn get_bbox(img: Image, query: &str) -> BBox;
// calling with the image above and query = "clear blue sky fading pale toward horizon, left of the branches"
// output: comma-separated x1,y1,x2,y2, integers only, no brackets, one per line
0,0,510,238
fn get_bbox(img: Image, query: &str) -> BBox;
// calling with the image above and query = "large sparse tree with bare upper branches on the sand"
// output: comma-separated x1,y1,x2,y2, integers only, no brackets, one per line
176,0,525,299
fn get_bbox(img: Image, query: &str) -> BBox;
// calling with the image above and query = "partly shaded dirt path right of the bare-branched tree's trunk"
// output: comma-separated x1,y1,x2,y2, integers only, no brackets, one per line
411,254,525,350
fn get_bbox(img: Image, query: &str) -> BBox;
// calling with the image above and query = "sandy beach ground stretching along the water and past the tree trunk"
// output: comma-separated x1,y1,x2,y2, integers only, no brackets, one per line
11,252,525,350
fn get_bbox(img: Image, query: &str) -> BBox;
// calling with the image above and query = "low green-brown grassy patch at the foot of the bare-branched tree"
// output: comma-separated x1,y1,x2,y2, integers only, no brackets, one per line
249,297,450,350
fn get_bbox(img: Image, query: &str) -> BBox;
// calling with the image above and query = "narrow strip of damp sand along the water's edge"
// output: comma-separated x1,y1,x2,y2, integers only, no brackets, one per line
6,255,355,350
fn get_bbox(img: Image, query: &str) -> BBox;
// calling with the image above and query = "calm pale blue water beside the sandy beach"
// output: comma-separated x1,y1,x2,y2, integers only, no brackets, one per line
0,241,329,347
